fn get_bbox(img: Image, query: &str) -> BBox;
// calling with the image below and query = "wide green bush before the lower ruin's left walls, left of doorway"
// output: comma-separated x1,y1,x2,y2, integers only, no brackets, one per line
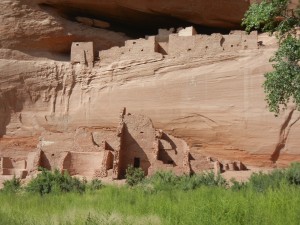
26,169,86,195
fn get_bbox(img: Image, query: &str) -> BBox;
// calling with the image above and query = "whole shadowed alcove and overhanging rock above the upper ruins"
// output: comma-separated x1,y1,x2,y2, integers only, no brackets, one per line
0,0,255,61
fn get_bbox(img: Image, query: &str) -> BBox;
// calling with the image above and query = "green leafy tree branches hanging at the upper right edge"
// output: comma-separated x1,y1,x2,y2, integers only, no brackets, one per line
242,0,300,116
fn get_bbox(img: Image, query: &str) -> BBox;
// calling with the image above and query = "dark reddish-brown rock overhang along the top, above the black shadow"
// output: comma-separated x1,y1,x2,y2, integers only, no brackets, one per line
38,0,250,28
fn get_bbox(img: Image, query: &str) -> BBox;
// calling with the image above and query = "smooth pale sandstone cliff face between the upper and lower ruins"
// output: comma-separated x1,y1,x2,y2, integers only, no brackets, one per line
0,33,300,168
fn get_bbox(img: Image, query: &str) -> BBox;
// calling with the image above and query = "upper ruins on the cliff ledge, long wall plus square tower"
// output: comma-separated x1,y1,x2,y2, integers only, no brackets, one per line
71,27,258,65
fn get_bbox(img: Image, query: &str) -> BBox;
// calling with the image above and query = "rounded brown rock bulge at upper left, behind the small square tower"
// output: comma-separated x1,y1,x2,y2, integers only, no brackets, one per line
0,0,128,57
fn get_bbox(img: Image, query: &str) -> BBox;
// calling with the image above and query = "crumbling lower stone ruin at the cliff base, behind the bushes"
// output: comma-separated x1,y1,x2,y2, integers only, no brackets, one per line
0,108,247,179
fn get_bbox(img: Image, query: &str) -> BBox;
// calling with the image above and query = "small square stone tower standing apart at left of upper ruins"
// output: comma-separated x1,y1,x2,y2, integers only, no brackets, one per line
71,42,94,66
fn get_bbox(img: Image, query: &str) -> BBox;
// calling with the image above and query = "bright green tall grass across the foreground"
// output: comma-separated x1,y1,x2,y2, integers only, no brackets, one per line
0,183,300,225
